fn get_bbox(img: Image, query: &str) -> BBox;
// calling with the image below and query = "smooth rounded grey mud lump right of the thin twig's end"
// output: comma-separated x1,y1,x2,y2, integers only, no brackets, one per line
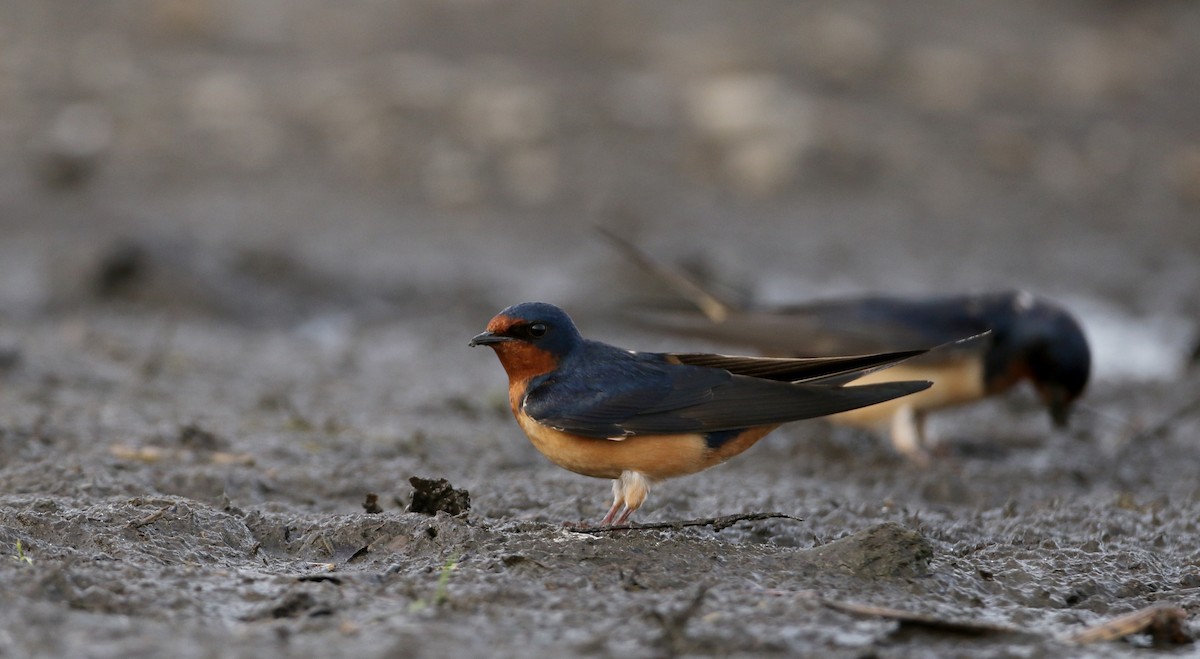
799,522,934,579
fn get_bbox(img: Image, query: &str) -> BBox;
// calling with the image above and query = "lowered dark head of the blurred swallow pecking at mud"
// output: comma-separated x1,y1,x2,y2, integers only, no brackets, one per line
988,293,1092,427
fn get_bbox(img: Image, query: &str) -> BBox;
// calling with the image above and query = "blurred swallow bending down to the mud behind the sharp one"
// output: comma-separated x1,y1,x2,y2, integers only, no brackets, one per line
597,233,1091,460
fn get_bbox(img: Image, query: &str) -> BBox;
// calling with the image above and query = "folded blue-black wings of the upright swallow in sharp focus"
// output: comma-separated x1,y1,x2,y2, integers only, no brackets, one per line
523,343,930,439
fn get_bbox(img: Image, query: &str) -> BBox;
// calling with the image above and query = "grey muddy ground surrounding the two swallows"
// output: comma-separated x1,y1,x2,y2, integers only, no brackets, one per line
0,0,1200,658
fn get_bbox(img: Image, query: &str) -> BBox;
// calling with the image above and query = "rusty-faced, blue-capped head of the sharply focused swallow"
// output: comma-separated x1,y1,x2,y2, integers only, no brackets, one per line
470,302,583,381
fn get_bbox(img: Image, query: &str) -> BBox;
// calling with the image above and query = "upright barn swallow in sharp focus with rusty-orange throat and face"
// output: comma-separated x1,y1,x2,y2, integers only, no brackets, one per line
470,302,930,525
